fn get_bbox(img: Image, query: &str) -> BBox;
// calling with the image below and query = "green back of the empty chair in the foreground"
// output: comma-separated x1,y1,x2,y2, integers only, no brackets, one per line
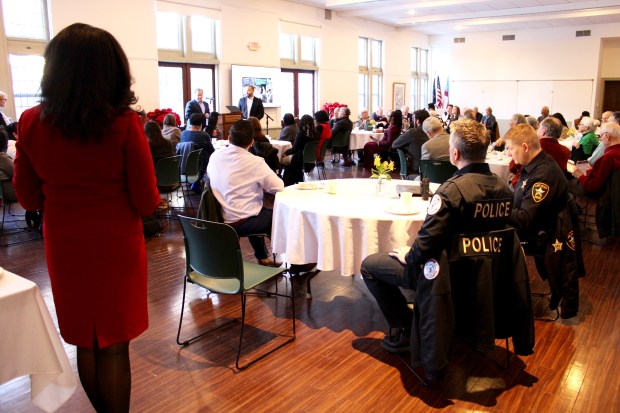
179,215,243,294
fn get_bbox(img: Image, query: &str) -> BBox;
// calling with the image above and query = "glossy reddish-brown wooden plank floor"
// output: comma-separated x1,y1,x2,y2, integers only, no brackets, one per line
0,159,620,412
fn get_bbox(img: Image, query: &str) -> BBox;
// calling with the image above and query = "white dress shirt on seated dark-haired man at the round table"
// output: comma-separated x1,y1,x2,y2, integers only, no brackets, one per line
207,144,284,223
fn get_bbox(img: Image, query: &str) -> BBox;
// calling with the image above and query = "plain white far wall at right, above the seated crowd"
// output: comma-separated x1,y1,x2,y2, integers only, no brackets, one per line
430,24,620,133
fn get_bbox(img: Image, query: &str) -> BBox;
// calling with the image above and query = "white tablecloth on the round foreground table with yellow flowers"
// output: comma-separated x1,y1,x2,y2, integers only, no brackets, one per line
271,179,437,275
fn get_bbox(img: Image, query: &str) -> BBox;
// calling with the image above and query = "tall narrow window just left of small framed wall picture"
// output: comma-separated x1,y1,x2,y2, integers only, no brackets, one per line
357,37,383,112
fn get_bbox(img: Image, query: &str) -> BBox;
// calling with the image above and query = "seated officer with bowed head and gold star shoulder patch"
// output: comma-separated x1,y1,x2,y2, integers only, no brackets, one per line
505,124,568,252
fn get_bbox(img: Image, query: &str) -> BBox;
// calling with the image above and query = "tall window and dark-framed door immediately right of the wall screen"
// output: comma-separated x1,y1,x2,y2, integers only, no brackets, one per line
280,21,319,117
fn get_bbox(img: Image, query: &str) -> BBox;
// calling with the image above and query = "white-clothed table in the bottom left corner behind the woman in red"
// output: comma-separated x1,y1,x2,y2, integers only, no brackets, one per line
0,267,77,412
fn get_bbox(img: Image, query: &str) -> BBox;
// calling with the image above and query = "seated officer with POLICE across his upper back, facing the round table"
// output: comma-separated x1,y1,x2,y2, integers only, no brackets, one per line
361,119,512,353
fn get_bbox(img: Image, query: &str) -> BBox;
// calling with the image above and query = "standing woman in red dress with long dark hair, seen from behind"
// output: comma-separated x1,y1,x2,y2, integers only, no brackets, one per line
13,23,159,412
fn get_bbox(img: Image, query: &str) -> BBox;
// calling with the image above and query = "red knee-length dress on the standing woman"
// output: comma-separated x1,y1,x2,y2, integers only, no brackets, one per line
13,106,159,348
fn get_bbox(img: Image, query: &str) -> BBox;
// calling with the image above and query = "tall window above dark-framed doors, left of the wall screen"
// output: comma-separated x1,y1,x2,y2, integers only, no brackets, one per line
156,2,219,123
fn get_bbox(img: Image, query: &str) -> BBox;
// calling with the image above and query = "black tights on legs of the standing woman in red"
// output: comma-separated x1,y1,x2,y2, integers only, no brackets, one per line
77,338,131,413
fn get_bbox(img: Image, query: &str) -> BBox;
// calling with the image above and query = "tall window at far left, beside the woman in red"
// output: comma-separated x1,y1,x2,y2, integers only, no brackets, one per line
2,0,49,120
